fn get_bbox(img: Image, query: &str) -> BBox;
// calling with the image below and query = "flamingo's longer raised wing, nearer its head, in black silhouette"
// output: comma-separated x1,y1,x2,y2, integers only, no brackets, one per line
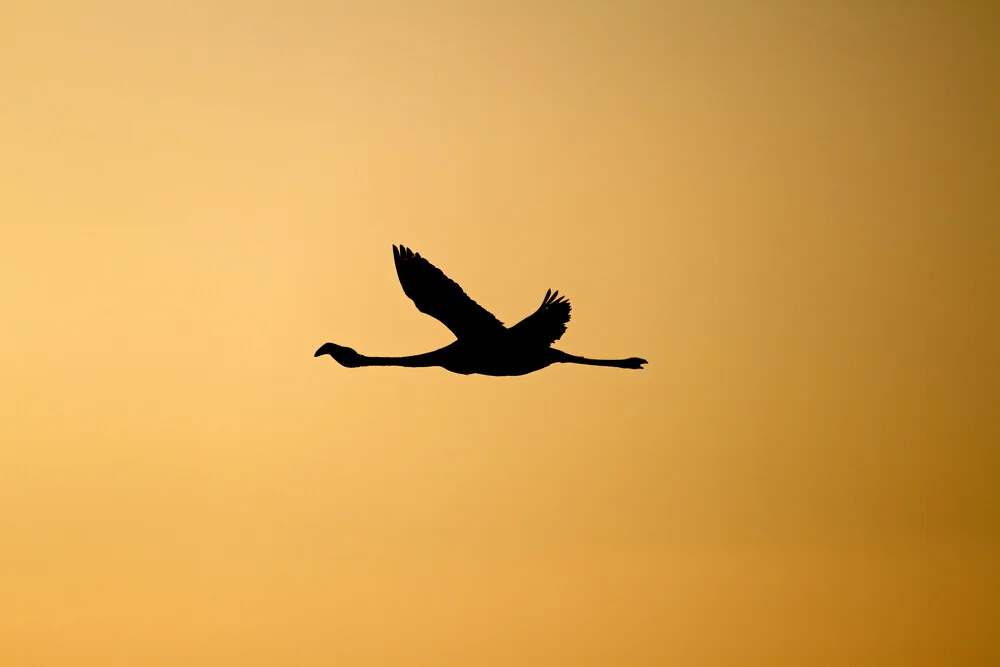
392,245,504,338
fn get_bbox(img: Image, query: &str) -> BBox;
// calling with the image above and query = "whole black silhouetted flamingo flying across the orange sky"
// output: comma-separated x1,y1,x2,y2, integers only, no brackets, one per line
313,245,647,376
